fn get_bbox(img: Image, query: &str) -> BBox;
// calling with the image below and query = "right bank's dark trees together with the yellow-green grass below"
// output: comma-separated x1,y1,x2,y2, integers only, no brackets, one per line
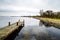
38,10,60,28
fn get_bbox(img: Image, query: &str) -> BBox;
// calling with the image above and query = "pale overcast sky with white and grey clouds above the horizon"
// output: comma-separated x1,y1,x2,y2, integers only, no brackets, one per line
0,0,60,16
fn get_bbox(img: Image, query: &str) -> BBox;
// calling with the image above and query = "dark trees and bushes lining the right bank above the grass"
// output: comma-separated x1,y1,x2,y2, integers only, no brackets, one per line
41,10,60,18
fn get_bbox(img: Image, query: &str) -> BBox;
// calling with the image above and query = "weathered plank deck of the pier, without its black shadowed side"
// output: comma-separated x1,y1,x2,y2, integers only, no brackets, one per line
0,21,24,40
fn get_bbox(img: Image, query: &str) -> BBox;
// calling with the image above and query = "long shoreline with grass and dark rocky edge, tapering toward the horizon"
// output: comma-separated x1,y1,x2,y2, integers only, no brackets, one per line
22,16,60,29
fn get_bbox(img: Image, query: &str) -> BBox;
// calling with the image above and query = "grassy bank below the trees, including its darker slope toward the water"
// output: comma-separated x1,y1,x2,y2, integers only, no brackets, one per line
33,17,60,28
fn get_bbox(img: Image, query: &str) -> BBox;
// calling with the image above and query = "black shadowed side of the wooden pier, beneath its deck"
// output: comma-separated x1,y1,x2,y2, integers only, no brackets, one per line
4,25,23,40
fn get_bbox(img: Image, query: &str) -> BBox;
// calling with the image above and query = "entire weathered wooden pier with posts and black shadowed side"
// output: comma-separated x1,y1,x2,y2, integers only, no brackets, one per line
0,21,24,40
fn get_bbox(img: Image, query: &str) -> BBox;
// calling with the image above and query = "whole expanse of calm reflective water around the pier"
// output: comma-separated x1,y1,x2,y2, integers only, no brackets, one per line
0,17,60,40
